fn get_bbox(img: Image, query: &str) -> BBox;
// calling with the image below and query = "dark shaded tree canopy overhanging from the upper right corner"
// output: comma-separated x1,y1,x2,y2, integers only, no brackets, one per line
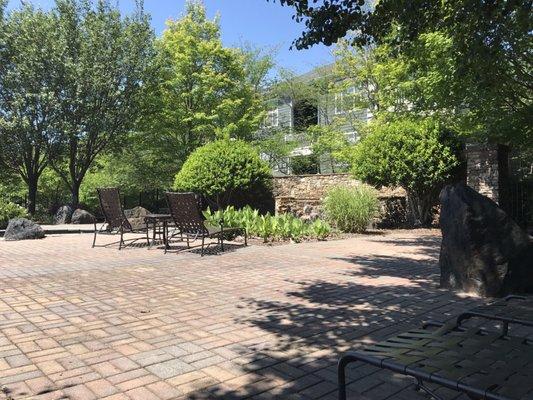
272,0,533,146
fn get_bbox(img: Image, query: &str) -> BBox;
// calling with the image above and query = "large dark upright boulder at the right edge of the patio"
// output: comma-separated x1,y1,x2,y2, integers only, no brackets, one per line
439,184,533,297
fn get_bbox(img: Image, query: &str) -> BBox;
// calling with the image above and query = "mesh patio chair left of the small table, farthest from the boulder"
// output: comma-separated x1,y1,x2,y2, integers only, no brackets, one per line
92,188,150,250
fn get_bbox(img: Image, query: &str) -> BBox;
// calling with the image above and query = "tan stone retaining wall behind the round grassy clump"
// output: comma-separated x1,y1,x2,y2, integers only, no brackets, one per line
273,174,407,227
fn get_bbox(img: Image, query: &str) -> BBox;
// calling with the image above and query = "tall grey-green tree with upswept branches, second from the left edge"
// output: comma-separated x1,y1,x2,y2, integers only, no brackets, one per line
50,0,153,205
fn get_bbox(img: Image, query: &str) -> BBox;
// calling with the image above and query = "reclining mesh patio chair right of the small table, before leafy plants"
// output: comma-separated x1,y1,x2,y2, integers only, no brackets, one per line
165,192,248,256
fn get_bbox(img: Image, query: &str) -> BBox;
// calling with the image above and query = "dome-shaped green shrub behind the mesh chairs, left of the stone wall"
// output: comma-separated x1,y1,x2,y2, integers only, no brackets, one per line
174,139,270,207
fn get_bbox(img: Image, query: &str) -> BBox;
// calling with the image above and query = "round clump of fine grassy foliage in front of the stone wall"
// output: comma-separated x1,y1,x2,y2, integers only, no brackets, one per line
323,185,379,233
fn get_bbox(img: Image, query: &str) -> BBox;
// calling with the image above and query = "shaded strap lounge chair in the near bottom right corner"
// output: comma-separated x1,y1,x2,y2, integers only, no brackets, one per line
338,322,533,400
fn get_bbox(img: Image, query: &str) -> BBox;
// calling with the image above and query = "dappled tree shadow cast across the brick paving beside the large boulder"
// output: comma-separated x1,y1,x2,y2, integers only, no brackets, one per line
186,248,479,399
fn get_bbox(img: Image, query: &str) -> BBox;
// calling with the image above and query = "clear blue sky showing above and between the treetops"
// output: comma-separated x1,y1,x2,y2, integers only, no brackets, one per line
5,0,333,73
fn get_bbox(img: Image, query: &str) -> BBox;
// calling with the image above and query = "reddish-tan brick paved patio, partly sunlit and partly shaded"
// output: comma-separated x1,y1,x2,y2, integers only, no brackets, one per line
0,231,477,400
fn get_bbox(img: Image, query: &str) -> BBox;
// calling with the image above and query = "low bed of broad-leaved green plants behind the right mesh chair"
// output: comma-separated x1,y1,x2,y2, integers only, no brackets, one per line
204,206,331,242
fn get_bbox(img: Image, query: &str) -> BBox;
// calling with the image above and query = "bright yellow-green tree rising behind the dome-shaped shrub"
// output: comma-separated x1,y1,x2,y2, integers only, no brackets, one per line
138,1,263,181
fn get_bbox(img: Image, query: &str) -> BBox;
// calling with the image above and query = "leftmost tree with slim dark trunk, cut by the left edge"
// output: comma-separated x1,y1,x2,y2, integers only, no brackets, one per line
0,1,58,214
